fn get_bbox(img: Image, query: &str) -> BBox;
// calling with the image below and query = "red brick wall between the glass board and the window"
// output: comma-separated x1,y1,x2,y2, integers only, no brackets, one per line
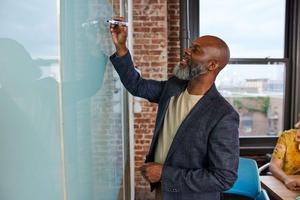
133,0,180,200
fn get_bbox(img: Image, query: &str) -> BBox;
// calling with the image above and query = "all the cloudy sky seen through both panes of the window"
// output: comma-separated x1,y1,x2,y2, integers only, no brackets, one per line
200,0,285,85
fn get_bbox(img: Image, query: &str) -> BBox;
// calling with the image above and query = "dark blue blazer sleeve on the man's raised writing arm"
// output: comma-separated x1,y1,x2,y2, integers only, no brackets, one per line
110,51,166,103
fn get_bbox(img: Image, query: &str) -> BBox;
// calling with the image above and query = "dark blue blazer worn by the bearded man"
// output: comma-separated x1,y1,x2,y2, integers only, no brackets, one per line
110,52,239,200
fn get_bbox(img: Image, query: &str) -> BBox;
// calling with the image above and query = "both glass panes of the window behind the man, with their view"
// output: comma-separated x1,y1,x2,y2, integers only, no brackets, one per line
199,0,288,137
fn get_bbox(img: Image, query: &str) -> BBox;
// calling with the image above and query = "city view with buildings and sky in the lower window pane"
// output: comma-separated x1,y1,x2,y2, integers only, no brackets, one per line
217,65,285,136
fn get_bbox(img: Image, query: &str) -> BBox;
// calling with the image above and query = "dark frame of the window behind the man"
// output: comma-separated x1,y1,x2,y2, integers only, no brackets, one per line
180,0,300,155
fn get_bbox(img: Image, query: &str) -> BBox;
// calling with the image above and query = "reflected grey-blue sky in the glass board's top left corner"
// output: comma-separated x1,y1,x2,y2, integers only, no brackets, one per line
0,0,58,58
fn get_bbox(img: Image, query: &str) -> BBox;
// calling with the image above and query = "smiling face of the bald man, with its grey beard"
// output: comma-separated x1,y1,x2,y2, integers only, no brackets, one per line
173,40,208,80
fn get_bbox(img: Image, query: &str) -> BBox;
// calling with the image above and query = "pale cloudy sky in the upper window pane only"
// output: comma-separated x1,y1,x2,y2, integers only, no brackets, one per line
200,0,285,58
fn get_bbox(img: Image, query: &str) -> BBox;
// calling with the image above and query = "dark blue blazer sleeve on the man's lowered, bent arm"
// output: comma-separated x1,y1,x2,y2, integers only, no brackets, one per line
161,111,239,192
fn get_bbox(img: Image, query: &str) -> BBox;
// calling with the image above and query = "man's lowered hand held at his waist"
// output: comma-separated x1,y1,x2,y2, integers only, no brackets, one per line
140,162,163,183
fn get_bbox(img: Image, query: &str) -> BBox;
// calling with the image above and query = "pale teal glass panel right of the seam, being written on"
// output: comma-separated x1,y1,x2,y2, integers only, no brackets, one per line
60,0,130,200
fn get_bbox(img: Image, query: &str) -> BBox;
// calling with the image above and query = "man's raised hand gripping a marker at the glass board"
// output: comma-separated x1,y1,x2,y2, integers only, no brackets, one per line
110,17,128,56
